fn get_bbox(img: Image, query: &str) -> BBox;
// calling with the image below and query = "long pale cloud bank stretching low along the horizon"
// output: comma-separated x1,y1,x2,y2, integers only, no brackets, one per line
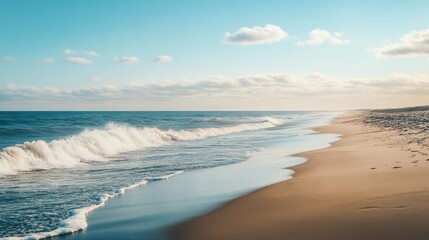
0,73,429,110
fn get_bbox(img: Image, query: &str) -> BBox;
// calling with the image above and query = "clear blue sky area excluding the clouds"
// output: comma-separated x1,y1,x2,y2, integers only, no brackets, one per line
0,0,429,109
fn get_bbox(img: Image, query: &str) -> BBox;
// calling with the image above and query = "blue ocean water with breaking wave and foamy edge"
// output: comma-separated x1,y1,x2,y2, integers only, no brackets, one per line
0,112,338,239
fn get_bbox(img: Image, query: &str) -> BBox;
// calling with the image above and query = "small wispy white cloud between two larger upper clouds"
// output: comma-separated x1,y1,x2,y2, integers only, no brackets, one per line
298,29,350,45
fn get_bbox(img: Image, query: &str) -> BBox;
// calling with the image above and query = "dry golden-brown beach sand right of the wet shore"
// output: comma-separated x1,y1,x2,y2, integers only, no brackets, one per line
173,111,429,240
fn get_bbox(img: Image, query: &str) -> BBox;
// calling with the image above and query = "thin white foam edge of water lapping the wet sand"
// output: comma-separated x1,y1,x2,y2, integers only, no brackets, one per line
3,171,183,240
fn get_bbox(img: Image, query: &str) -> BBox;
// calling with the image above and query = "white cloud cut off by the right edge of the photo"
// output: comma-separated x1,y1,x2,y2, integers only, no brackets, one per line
373,29,429,58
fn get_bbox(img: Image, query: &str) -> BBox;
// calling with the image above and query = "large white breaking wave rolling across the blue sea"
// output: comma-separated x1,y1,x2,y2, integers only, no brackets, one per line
0,117,282,176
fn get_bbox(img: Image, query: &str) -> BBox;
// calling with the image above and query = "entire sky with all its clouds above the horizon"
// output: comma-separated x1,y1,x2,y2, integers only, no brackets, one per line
0,0,429,110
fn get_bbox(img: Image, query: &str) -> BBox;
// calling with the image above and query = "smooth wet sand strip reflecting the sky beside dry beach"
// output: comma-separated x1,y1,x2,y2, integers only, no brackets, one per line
56,113,338,240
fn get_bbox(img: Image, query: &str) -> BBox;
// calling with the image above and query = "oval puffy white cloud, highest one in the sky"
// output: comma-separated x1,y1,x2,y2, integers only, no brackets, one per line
224,24,288,45
